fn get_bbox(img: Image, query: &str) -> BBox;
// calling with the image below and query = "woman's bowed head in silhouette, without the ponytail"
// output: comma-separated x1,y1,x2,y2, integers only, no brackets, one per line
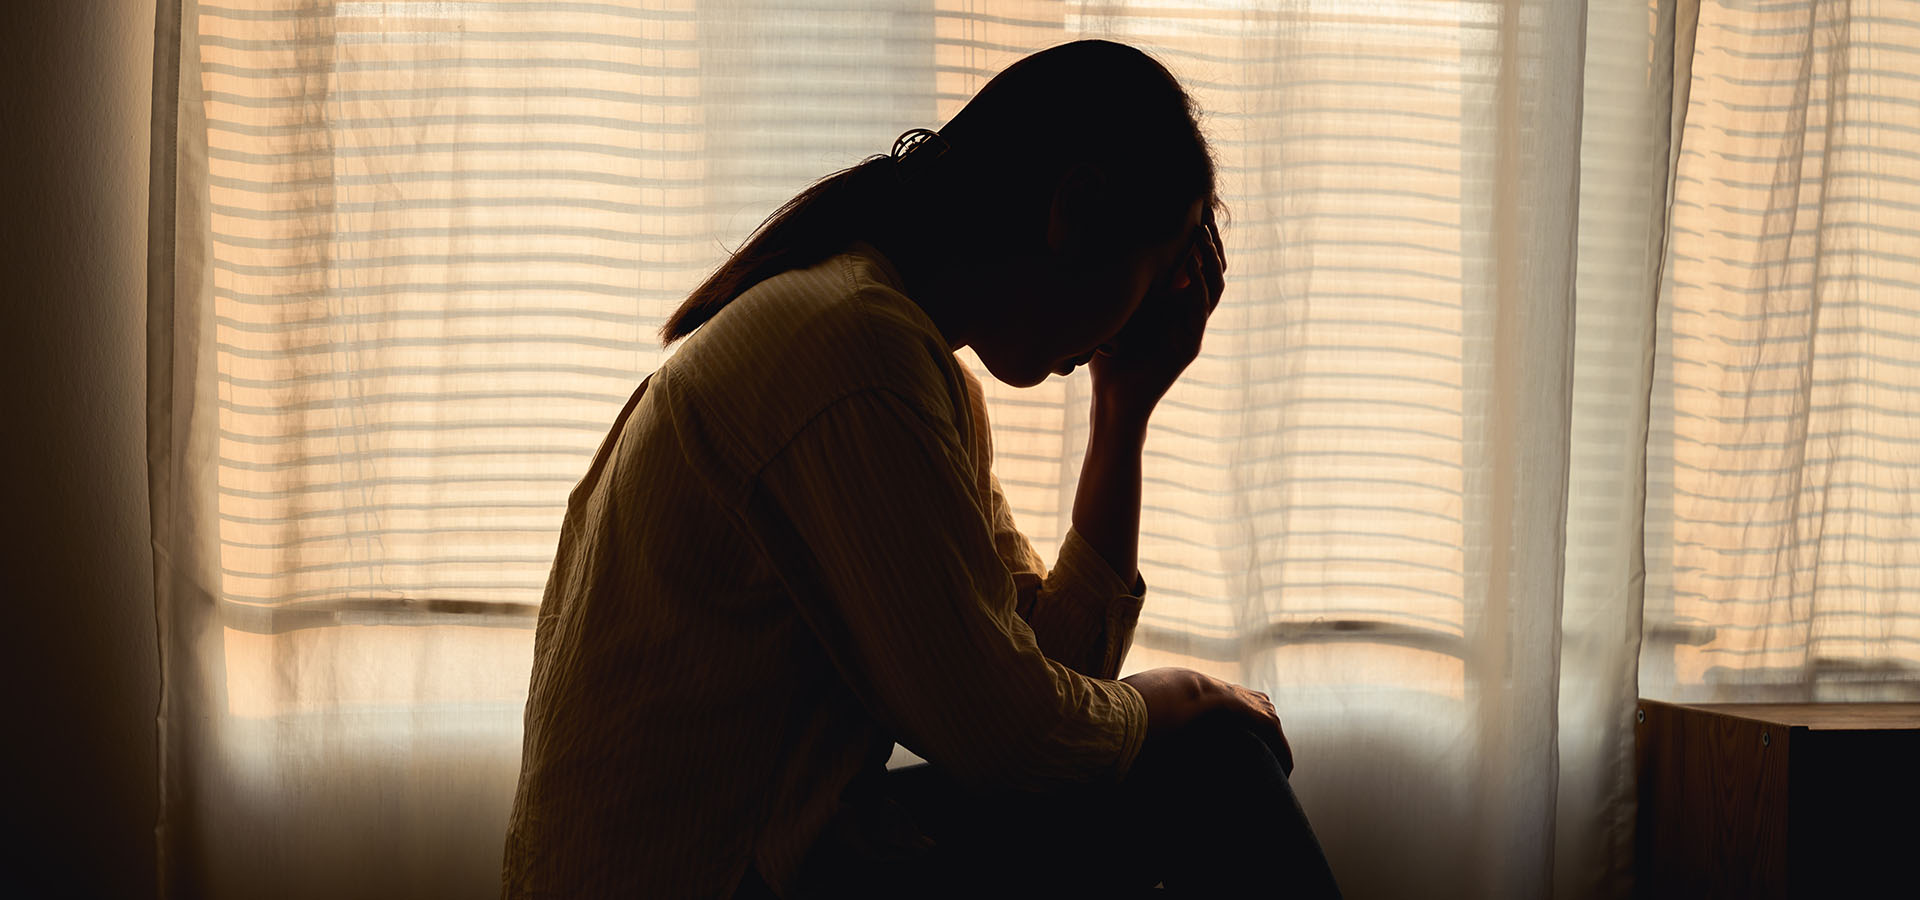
935,40,1215,386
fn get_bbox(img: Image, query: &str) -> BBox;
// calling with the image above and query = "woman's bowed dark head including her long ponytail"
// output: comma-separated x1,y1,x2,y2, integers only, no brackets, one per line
662,40,1217,384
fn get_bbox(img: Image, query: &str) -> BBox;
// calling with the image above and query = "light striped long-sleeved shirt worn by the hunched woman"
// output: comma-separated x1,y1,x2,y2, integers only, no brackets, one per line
503,244,1146,898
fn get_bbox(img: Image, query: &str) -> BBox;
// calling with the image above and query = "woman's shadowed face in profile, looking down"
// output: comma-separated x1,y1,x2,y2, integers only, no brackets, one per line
970,201,1206,388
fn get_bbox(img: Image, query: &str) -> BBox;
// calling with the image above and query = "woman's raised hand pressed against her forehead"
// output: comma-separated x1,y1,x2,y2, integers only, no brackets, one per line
1089,211,1227,420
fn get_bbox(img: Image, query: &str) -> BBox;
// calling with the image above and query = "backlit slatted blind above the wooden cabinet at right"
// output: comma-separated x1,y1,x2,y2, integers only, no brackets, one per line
1644,0,1920,699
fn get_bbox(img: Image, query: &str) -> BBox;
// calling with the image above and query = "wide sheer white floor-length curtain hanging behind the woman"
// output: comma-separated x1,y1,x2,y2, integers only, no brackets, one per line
150,0,1674,898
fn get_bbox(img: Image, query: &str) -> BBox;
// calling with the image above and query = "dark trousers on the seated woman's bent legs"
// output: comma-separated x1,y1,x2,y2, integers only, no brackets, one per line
737,722,1340,898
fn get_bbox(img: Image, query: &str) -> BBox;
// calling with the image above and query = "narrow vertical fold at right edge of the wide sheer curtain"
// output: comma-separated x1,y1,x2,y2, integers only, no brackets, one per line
1553,0,1695,886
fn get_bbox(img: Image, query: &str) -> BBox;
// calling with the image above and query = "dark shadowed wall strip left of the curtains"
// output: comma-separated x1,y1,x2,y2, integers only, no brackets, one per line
0,0,159,898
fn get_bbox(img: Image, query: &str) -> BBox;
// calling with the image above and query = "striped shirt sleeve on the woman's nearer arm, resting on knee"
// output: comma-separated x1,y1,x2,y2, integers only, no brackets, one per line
747,390,1146,789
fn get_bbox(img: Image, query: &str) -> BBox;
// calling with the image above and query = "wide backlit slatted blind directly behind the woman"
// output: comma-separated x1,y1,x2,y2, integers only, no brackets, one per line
200,0,1566,710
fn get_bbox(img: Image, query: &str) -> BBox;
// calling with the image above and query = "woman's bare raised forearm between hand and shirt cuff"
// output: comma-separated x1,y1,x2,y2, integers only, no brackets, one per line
1073,393,1150,581
